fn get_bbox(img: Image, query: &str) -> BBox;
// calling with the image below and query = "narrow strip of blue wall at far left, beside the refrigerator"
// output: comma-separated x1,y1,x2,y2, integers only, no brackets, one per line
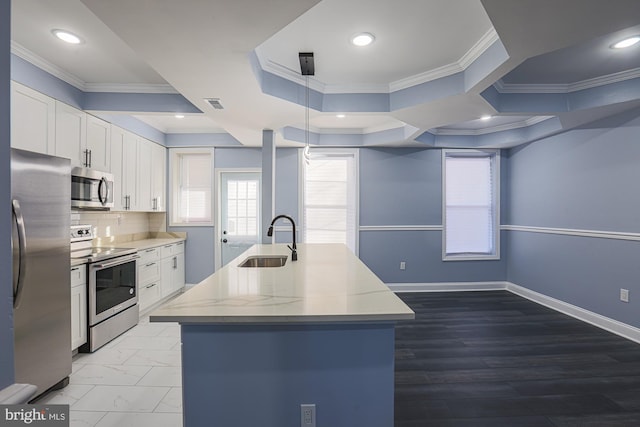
0,0,13,389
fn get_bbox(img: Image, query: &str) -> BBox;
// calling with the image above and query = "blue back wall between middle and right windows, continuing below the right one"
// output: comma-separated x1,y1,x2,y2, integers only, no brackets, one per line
360,148,507,283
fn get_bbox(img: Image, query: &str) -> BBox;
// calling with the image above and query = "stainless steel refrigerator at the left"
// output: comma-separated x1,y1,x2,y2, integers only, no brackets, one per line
11,149,71,395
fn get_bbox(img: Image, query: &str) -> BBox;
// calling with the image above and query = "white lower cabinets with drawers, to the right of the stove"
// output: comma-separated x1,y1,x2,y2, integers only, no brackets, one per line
138,242,185,312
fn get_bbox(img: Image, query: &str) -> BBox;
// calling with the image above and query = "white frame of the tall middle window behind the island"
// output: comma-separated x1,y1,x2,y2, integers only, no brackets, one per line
298,148,360,256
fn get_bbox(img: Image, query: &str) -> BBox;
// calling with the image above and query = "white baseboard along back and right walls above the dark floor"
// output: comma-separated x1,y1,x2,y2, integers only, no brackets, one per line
386,282,640,343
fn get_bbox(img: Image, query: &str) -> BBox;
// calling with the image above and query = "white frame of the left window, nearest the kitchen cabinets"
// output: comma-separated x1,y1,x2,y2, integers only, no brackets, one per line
169,148,215,227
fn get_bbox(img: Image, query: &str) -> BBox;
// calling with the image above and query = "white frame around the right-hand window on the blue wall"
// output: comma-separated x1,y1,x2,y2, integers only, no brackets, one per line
442,149,500,261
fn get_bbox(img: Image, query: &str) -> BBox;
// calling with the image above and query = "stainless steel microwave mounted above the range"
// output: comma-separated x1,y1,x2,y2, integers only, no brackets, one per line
71,167,113,210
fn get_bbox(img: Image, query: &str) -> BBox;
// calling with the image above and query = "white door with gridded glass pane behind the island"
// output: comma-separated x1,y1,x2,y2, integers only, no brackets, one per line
218,172,260,266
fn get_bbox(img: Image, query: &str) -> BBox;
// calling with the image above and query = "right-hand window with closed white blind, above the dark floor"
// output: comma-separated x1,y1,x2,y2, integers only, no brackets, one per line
442,150,500,260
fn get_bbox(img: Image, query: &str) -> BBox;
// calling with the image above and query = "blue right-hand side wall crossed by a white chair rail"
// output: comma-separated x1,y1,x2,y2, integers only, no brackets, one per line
503,110,640,327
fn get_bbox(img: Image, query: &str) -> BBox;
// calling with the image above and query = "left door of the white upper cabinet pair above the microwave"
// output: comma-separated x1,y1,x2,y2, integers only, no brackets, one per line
55,101,87,166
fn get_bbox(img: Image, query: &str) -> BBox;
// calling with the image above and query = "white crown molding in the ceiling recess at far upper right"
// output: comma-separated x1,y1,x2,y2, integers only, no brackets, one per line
493,68,640,93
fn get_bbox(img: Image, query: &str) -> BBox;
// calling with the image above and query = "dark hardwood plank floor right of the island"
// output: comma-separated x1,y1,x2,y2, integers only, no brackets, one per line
395,291,640,427
